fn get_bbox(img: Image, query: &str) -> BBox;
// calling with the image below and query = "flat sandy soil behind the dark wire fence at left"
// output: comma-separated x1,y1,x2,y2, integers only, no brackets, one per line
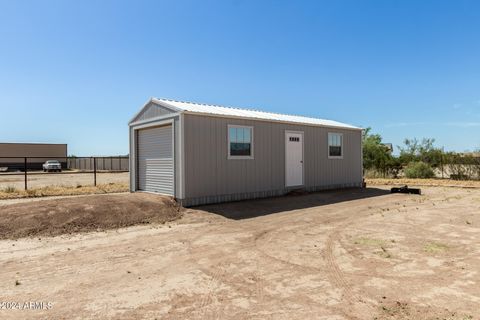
0,172,129,189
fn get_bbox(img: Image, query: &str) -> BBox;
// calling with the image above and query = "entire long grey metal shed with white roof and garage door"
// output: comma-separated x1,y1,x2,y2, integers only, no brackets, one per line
129,98,363,206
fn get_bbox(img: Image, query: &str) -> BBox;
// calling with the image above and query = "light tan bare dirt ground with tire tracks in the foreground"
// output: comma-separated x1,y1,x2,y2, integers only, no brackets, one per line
0,188,480,320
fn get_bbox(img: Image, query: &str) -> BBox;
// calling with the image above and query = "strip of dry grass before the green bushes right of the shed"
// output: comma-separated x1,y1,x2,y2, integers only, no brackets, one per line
365,178,480,188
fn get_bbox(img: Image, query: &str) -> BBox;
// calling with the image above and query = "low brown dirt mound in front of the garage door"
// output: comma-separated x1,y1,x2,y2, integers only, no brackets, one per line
0,193,181,239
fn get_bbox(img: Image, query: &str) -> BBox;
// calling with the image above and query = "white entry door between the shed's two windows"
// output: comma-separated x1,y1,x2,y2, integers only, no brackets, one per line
285,131,303,187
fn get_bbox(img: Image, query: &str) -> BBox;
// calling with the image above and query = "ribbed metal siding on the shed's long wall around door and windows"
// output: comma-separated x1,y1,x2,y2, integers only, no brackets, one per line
184,115,362,202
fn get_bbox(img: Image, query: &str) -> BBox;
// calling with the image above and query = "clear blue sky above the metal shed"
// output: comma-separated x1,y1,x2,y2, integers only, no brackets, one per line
0,0,480,155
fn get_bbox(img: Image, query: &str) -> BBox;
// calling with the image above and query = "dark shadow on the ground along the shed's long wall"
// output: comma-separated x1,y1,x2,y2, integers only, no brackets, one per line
196,188,390,220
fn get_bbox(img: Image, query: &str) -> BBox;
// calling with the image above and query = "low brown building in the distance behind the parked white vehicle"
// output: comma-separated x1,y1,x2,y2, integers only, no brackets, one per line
0,143,67,171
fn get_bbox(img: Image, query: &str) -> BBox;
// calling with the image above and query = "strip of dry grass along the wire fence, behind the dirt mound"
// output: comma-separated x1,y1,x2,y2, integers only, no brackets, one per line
0,183,128,200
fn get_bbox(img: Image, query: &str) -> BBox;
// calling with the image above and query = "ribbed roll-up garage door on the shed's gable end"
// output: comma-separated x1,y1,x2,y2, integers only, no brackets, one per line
137,125,174,196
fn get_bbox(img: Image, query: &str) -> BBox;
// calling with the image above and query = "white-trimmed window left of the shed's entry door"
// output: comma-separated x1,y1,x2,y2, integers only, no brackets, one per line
228,125,253,159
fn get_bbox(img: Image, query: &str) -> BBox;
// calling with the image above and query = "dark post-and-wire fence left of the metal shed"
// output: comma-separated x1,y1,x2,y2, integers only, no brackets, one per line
0,156,129,190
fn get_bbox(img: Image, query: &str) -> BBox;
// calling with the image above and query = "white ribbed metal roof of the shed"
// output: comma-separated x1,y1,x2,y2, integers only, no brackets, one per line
152,98,361,130
